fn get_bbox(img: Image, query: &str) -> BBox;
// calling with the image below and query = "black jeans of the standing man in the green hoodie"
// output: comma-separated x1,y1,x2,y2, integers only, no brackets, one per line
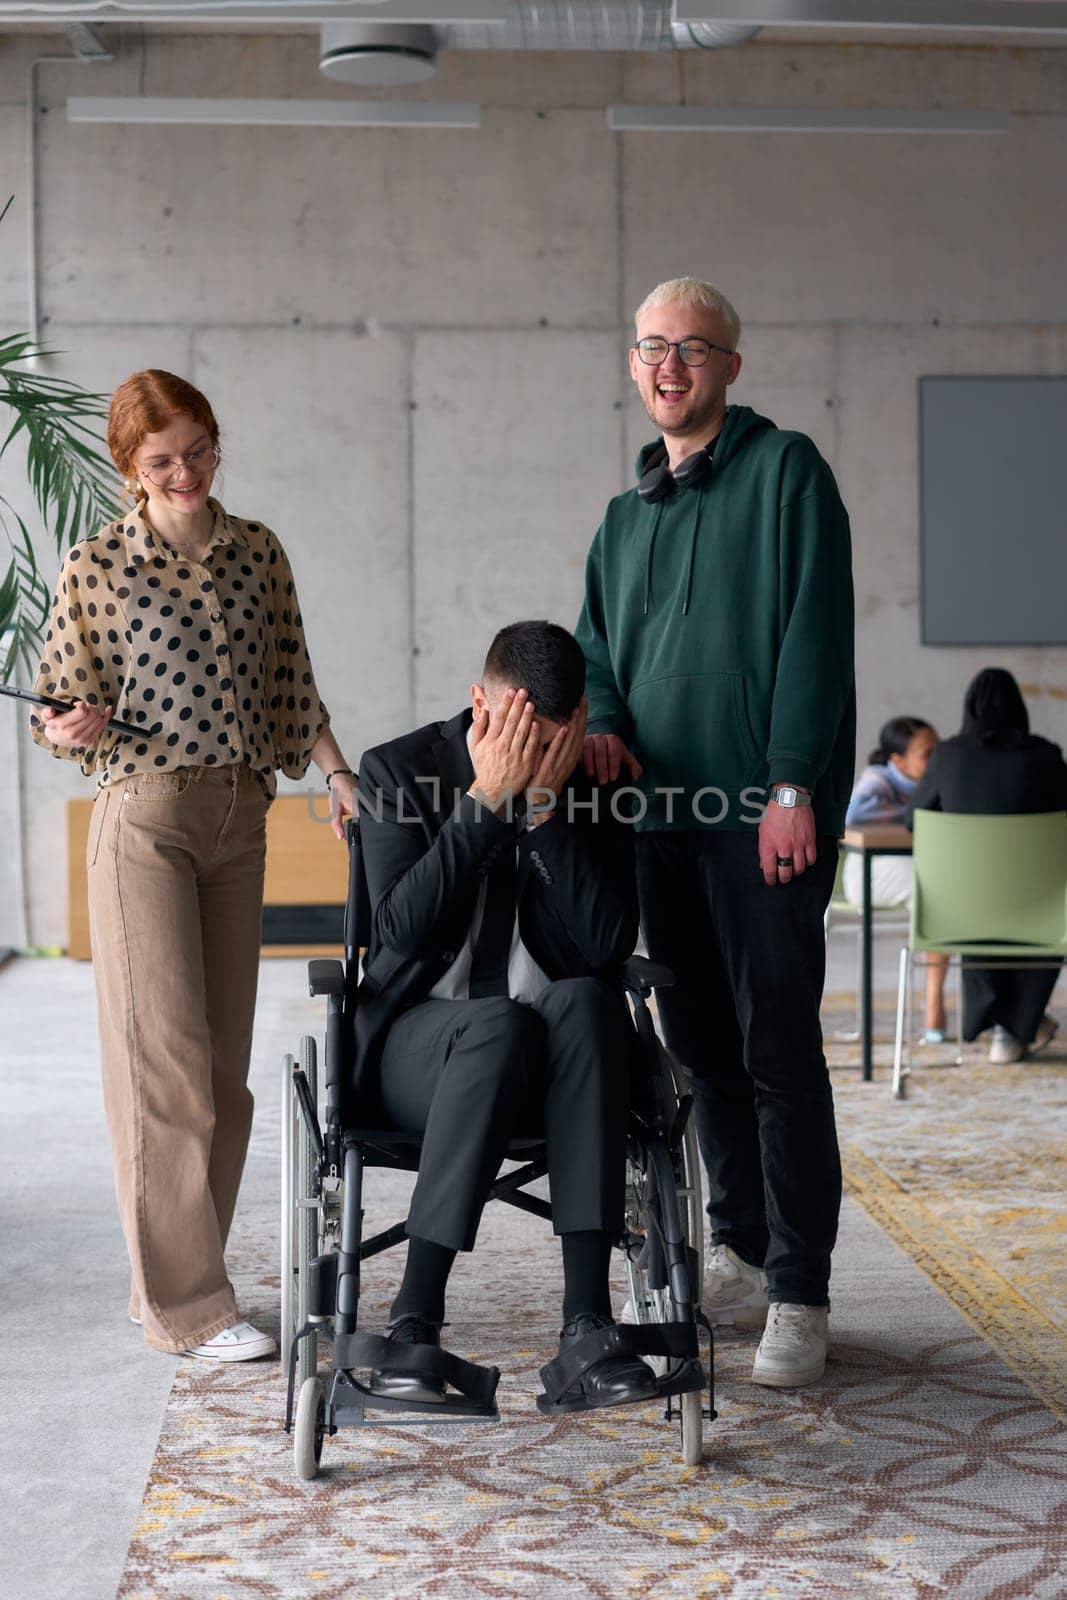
637,827,841,1306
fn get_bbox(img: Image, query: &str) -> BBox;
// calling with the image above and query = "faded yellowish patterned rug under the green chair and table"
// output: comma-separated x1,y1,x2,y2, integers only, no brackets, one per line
824,995,1067,1421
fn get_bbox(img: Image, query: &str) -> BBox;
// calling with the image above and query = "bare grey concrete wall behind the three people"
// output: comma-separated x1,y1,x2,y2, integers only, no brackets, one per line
0,29,1067,942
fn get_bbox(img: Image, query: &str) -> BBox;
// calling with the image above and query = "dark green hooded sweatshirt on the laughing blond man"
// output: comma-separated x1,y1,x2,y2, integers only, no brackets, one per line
576,406,856,834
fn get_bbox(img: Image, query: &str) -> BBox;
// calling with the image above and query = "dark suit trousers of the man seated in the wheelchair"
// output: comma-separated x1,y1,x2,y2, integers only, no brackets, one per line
381,978,633,1250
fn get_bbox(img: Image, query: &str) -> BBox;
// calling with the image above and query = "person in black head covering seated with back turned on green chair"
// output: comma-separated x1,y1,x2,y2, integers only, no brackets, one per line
912,667,1067,1064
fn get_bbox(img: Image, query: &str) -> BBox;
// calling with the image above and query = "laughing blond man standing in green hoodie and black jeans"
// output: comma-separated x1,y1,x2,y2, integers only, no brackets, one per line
577,278,856,1387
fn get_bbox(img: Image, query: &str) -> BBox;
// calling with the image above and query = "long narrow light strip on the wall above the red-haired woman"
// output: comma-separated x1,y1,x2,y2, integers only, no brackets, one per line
67,94,482,128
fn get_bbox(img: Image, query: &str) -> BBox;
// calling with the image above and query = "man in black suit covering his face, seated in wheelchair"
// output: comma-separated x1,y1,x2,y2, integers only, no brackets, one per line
355,622,656,1410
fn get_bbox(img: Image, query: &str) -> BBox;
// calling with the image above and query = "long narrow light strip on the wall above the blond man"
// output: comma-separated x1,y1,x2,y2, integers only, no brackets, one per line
608,106,1009,133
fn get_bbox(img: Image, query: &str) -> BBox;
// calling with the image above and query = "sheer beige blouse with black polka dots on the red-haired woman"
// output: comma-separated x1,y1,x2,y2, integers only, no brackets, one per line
30,501,330,792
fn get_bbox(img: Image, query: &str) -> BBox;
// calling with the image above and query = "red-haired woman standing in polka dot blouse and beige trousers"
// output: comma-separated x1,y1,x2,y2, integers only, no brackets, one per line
32,371,352,1362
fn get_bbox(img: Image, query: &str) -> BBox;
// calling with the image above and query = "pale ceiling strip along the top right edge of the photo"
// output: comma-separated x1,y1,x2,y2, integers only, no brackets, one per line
673,0,1067,34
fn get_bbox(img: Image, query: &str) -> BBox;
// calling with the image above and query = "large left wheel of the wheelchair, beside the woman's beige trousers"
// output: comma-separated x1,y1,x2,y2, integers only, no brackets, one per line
280,1037,318,1386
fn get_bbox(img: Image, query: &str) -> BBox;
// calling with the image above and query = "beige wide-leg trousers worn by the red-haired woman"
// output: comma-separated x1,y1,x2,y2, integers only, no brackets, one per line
88,766,269,1350
